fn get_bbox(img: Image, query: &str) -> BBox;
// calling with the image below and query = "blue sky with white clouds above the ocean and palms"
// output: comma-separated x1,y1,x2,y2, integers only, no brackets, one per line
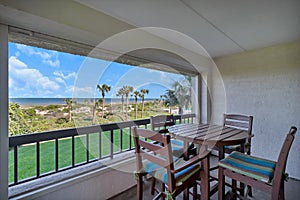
9,43,183,98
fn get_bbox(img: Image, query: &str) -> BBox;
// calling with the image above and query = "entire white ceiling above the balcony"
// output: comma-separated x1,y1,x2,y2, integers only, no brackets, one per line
0,0,300,72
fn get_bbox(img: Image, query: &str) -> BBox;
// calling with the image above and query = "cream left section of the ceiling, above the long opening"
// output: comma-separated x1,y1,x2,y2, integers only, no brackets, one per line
0,0,135,46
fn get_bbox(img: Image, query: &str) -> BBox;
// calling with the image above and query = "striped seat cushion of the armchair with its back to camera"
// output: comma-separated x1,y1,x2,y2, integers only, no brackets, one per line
143,157,201,186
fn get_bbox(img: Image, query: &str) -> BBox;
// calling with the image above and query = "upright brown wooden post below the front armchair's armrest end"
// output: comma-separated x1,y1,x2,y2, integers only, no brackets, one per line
200,156,210,200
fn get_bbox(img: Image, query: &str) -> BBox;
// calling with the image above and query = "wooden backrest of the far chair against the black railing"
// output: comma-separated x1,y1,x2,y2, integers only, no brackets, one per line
150,115,175,133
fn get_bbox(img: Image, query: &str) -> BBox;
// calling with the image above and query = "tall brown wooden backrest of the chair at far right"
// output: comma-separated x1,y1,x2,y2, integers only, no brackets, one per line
273,126,297,194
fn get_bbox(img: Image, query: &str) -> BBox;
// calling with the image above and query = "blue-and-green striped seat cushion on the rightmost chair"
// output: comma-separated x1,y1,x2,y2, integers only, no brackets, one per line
219,151,276,183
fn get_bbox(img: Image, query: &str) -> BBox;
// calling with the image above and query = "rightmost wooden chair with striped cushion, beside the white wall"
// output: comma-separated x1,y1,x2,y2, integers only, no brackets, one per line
218,127,297,200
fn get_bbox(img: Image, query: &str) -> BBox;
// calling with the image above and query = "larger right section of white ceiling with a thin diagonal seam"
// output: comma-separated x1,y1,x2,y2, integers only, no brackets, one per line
77,0,300,57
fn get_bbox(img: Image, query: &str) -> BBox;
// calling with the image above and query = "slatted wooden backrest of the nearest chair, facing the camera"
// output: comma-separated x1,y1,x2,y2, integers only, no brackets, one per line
133,127,175,189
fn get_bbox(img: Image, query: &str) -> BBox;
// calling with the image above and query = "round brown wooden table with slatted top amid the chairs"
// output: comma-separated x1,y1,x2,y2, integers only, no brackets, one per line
168,124,249,199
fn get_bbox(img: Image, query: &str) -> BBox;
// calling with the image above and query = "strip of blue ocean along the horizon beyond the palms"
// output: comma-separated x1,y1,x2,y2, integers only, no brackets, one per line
9,98,155,106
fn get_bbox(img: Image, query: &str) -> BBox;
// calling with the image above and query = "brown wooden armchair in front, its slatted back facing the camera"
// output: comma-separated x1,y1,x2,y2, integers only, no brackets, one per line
133,127,209,200
